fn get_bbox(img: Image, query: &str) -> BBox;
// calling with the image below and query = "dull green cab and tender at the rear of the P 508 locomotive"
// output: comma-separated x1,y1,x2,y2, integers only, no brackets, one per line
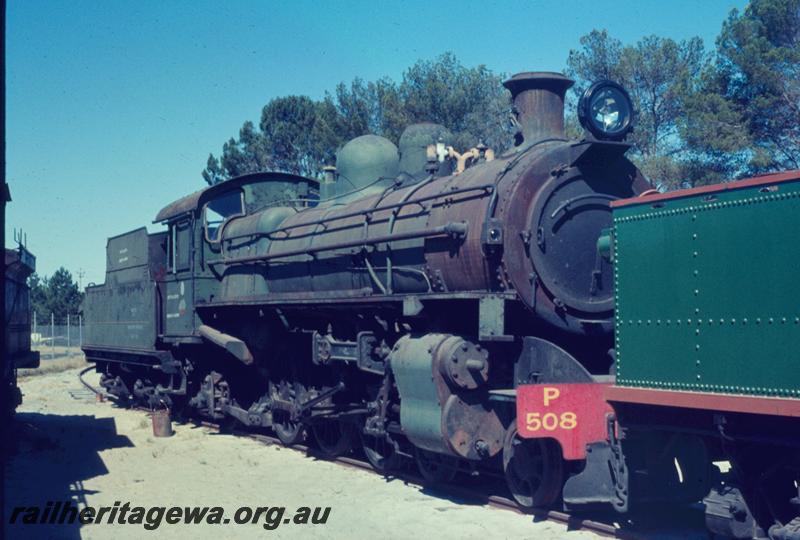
83,173,318,405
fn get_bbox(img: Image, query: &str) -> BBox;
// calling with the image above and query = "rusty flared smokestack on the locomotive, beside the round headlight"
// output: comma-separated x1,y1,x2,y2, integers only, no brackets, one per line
503,71,575,146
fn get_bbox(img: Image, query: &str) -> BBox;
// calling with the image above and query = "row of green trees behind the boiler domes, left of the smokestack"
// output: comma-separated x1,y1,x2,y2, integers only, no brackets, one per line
203,53,511,184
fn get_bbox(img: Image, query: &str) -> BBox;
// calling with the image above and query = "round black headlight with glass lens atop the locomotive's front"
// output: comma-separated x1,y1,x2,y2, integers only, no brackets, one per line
578,81,633,141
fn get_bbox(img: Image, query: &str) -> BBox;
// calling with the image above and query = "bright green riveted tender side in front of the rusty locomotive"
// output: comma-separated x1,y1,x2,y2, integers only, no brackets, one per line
613,181,800,397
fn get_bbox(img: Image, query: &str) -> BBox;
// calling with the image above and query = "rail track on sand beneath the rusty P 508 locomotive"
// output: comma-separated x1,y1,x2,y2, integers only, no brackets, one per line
78,365,692,540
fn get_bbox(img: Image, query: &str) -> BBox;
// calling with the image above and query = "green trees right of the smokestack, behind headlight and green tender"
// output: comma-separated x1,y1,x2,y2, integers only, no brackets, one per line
567,0,800,189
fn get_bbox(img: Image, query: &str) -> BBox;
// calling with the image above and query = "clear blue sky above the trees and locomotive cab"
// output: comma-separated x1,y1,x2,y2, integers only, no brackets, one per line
6,0,745,285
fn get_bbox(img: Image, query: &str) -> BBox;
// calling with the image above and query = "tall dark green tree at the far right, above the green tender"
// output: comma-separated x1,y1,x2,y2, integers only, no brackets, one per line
681,0,800,177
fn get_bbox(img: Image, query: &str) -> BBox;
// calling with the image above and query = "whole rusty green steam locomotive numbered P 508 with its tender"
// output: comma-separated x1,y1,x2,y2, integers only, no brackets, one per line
84,73,649,506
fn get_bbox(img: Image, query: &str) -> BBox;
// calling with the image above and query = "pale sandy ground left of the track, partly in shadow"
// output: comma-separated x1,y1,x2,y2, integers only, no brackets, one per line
5,369,599,540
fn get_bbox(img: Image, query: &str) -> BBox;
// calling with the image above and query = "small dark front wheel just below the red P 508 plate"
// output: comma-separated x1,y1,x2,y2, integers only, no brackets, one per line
503,422,564,510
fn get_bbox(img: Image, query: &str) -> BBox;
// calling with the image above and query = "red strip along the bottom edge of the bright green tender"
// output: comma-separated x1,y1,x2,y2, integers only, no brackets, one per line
605,386,800,417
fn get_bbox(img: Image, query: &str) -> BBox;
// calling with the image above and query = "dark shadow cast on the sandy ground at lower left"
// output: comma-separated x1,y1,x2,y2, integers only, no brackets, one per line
3,413,133,539
